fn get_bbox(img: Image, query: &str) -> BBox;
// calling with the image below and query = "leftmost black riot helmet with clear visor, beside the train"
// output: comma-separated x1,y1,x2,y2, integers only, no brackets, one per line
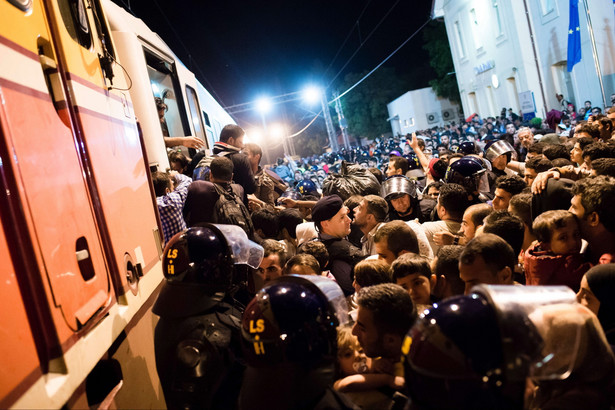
152,224,263,317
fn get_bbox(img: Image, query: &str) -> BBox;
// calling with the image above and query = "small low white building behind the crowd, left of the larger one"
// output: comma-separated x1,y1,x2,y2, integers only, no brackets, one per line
387,87,460,135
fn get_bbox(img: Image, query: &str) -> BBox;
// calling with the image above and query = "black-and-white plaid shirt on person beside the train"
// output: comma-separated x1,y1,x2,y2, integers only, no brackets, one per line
156,174,192,246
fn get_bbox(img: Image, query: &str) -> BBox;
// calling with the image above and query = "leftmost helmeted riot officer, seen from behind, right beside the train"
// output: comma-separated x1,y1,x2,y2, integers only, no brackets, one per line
152,224,263,409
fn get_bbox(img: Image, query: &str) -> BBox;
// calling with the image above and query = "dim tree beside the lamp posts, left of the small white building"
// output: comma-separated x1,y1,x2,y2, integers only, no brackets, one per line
334,67,408,139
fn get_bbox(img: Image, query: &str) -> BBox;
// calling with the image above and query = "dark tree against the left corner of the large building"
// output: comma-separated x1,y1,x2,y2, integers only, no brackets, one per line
423,20,461,103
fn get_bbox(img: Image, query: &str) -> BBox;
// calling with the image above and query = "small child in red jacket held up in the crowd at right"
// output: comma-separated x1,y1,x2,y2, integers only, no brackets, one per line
524,210,591,292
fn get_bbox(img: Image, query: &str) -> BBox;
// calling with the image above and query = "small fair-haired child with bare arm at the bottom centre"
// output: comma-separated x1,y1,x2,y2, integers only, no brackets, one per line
333,326,404,408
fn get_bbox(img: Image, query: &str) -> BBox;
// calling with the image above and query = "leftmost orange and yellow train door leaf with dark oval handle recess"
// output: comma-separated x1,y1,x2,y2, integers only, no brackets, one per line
0,0,111,350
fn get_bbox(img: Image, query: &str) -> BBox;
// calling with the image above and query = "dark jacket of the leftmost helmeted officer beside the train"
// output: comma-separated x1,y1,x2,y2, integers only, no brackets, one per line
154,295,245,410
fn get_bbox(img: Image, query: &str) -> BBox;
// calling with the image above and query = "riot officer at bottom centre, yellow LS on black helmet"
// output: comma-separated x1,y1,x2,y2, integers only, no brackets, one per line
239,275,356,410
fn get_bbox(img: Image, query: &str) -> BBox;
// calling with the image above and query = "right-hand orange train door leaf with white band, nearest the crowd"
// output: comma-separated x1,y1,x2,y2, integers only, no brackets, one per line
46,0,162,303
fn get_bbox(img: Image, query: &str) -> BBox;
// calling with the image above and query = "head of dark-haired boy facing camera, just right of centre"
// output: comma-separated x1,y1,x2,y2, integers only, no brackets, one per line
391,253,436,311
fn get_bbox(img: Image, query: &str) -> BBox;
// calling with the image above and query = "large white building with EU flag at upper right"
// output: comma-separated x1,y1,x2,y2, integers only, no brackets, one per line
433,0,615,118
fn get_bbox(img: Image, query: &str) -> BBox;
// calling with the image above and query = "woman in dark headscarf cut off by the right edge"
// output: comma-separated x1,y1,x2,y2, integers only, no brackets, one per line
577,263,615,347
